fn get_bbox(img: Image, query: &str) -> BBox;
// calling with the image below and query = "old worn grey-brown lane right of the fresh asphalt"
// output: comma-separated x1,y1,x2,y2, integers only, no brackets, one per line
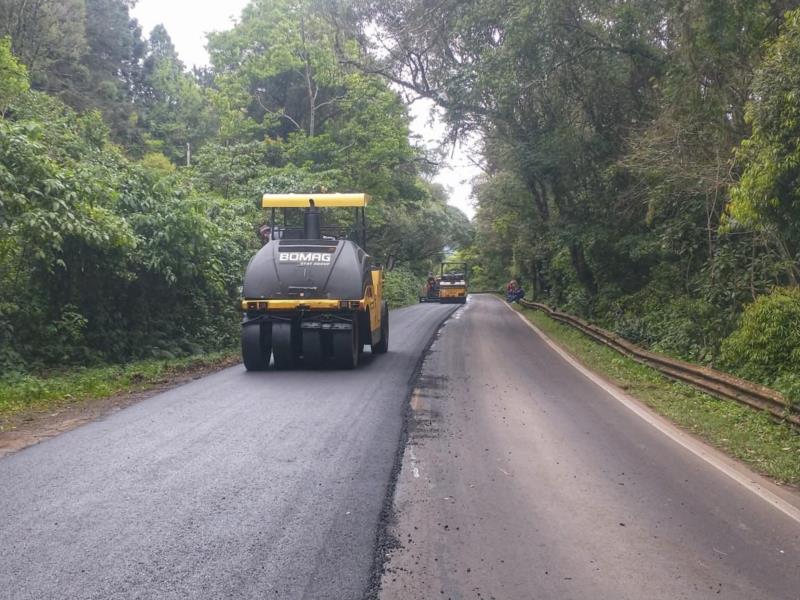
381,296,800,600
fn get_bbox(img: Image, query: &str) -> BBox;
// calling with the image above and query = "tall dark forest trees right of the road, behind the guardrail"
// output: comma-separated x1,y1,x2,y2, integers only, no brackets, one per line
362,0,800,392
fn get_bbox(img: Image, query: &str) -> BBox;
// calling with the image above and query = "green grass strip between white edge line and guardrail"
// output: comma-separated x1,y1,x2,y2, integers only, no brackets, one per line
518,308,800,485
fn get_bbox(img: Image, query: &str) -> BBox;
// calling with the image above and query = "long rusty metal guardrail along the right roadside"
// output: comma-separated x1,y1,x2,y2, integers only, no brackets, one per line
519,300,800,427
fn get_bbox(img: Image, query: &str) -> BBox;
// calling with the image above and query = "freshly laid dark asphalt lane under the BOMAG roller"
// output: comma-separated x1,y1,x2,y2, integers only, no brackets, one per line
0,305,454,600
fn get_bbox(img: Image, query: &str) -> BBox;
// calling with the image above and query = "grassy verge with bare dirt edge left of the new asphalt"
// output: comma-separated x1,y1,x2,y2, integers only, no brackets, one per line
0,350,238,431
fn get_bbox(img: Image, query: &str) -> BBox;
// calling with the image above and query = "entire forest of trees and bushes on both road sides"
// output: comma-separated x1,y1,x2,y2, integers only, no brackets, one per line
0,0,800,406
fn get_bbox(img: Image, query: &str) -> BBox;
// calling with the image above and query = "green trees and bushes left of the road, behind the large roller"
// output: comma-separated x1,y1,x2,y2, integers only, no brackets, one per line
0,0,470,373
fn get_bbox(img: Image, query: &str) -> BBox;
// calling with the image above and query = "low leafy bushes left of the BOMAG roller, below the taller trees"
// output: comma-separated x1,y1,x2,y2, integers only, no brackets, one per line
0,85,255,368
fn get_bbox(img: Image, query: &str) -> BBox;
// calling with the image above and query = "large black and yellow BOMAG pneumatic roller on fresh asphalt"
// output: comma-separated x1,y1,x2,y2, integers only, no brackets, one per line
241,194,389,371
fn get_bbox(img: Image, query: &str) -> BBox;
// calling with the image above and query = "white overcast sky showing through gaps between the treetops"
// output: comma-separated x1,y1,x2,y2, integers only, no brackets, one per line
131,0,479,217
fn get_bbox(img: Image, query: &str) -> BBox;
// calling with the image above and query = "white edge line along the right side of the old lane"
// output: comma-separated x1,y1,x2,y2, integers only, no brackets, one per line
497,299,800,523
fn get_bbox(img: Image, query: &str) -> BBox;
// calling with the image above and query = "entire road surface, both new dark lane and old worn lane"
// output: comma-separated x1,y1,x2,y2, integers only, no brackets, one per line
0,296,800,600
